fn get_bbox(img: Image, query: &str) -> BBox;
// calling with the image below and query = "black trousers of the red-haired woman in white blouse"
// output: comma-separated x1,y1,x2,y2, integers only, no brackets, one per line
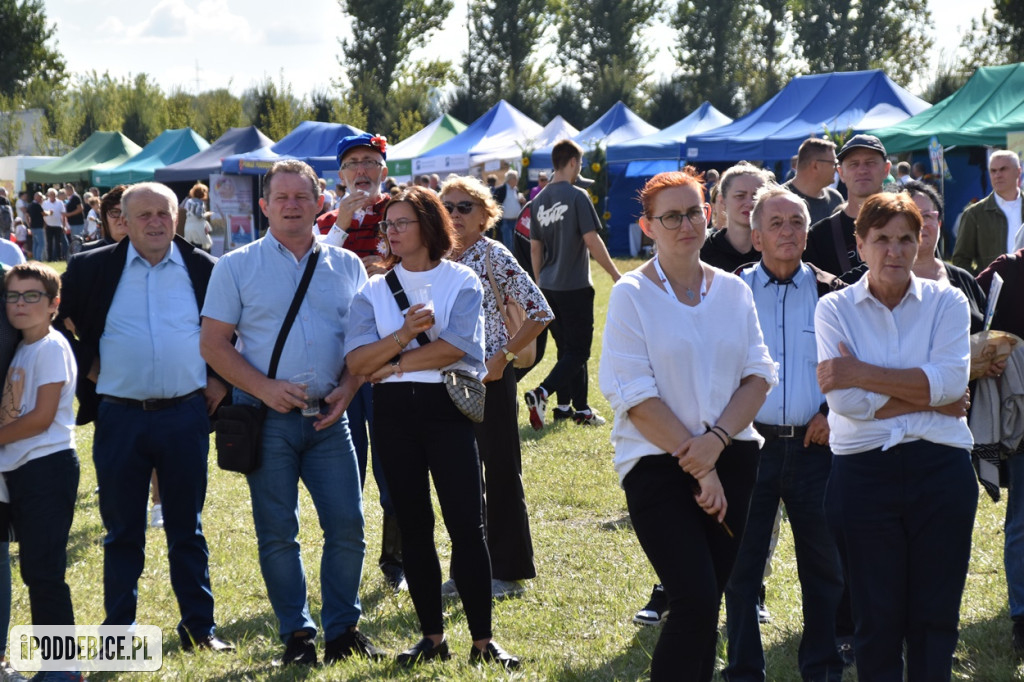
623,440,758,682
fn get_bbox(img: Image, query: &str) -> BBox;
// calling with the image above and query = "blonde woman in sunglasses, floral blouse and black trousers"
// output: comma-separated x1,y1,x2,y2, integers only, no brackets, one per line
440,176,554,598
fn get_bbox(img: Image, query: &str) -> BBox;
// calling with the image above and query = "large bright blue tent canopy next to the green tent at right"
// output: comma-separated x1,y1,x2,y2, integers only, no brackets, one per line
686,70,931,162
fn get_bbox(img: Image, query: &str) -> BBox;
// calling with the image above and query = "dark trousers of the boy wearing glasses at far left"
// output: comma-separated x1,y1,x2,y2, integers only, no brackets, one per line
6,450,79,625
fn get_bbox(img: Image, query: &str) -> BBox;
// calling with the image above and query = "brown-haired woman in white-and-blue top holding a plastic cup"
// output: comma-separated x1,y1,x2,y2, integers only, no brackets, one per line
345,186,519,669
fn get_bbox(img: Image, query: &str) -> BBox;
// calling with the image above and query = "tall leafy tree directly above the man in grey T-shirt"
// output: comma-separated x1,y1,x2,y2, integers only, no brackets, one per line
552,0,659,116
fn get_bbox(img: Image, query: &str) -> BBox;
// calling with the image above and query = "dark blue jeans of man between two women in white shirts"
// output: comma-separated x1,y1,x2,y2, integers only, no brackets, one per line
724,438,843,682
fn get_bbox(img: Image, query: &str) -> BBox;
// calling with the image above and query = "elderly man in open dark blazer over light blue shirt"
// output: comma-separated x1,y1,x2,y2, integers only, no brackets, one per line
56,182,233,651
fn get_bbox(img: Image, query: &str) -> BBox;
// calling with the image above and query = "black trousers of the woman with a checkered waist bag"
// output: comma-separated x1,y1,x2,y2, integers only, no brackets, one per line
373,382,490,640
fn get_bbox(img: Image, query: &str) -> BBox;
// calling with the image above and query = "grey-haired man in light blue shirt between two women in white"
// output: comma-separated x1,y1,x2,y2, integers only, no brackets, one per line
724,185,845,682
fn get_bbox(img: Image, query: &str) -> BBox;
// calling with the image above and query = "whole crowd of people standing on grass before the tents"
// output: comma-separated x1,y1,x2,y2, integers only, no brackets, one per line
0,129,1024,682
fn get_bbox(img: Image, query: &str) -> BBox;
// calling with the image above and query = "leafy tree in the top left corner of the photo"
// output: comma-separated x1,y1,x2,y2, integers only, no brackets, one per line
0,0,67,95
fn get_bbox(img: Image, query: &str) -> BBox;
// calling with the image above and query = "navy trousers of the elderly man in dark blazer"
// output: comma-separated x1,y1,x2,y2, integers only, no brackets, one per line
92,395,214,640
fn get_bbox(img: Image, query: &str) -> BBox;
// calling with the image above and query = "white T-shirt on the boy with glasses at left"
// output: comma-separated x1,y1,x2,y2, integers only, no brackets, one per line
0,329,78,471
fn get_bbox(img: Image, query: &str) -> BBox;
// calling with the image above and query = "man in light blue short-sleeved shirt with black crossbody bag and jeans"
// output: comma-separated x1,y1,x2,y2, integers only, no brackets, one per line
202,161,380,666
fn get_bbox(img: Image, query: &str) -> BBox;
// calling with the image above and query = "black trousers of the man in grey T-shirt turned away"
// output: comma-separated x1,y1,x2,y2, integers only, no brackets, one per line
541,287,594,411
